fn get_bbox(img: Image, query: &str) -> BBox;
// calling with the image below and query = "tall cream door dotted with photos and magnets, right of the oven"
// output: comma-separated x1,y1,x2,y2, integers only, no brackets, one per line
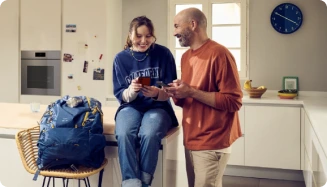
61,0,110,102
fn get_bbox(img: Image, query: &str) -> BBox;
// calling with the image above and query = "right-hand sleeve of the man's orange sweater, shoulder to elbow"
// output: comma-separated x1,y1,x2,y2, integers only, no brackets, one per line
215,49,243,112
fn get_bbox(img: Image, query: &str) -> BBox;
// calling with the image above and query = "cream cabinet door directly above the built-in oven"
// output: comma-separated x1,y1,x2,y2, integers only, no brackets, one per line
20,0,61,50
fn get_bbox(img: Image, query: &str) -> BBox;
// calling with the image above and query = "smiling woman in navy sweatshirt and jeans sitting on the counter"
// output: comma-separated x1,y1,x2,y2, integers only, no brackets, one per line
113,16,177,187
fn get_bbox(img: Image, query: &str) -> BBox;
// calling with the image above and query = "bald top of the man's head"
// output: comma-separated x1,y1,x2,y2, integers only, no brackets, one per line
177,8,207,29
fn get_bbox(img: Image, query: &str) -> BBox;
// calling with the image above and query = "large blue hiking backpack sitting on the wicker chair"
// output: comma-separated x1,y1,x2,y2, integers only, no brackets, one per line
36,96,106,177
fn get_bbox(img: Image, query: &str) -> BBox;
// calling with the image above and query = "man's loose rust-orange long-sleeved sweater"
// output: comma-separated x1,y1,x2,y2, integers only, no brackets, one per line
174,40,242,150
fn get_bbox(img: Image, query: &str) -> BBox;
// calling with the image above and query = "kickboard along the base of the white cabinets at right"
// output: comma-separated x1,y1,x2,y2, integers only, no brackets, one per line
224,165,304,181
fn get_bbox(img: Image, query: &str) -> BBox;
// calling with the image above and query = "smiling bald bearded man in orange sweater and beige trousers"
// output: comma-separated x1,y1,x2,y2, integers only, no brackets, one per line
165,8,242,187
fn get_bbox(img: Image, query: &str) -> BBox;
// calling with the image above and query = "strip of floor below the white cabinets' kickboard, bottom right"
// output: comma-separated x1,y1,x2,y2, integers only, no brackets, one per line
223,176,305,187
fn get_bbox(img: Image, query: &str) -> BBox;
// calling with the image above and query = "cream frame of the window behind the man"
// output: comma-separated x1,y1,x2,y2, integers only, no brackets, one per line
167,0,249,80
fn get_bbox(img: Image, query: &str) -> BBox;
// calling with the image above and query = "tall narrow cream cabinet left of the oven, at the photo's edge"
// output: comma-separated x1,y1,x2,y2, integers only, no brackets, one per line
0,0,20,103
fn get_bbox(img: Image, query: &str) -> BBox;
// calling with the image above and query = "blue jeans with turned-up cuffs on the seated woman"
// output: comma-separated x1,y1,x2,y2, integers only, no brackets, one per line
115,107,172,187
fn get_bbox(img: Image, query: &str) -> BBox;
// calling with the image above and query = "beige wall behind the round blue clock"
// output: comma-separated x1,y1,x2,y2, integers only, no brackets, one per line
249,0,327,91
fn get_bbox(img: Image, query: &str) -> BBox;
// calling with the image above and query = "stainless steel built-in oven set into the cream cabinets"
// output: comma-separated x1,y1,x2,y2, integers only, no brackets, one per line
21,51,61,96
